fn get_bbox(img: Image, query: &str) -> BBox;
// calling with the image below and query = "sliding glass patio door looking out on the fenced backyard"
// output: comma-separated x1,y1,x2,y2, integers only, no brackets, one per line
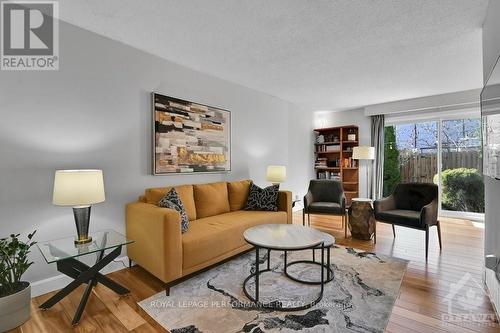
384,118,484,218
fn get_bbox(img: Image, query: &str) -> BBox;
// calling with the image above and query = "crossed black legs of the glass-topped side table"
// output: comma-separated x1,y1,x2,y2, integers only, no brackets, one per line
40,246,130,325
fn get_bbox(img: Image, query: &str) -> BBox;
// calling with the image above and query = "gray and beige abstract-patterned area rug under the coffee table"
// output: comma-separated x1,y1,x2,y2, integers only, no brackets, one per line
139,246,408,333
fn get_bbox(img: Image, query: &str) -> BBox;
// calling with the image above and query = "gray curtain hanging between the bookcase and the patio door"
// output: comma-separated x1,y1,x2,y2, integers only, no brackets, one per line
371,114,385,200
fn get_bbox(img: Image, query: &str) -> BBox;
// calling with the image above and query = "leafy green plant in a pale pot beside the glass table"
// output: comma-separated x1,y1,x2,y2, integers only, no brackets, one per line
0,231,36,332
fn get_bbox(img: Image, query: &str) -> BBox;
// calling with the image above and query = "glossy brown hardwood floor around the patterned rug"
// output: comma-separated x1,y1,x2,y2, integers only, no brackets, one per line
12,212,500,333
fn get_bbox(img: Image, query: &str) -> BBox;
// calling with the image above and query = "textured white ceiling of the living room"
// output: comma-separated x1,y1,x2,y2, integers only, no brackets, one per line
60,0,488,109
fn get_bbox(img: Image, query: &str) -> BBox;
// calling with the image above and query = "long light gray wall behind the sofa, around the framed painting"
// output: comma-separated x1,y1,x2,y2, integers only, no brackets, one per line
0,22,312,281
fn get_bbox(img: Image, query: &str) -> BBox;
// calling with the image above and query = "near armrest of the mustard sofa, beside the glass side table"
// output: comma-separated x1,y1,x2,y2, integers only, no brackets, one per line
126,202,182,282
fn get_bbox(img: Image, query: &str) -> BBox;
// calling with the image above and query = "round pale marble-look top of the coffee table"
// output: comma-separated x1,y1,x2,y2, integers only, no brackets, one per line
243,224,333,250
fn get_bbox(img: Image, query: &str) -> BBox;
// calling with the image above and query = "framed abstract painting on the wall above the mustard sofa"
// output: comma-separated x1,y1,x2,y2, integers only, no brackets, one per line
152,93,231,175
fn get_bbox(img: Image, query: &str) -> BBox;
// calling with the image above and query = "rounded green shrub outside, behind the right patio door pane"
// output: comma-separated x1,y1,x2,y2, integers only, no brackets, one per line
434,168,484,213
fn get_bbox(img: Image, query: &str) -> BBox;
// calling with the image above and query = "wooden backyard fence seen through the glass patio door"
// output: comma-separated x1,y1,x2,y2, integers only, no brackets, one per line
399,150,481,183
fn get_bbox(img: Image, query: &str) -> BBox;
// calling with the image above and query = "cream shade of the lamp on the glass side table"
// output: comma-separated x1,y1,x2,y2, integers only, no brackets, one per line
52,170,105,207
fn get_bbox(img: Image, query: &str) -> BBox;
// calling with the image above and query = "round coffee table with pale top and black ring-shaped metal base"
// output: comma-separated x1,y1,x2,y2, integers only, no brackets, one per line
243,224,335,311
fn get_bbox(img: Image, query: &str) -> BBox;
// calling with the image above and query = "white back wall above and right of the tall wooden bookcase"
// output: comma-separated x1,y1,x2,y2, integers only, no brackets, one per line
314,109,371,198
